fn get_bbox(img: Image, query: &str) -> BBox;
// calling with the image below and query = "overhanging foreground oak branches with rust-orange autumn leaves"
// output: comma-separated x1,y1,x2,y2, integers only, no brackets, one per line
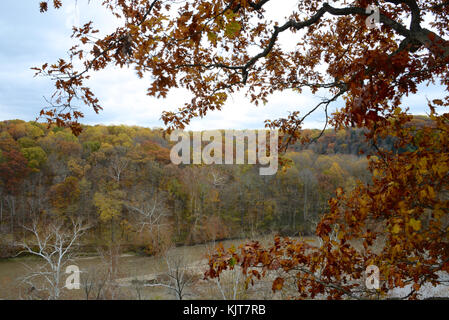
36,0,449,298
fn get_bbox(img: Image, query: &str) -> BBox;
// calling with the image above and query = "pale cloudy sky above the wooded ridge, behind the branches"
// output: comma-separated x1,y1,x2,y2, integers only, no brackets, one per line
0,0,441,130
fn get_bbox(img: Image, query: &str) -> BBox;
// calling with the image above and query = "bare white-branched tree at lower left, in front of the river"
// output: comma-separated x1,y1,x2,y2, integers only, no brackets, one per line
19,218,88,300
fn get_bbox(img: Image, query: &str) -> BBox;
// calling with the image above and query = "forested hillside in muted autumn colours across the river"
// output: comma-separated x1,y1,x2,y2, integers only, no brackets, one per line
0,120,382,256
